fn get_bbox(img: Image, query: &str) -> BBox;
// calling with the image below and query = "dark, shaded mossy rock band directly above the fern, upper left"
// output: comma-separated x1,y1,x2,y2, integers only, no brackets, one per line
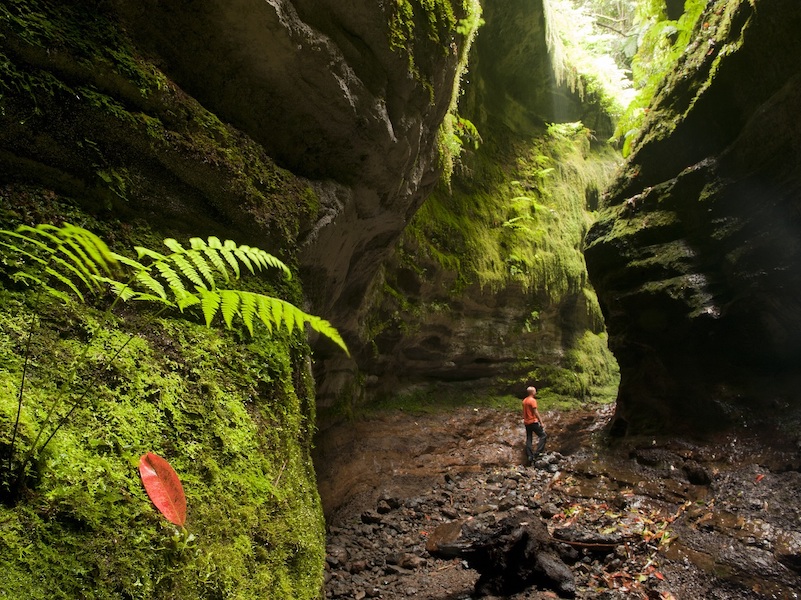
0,0,319,243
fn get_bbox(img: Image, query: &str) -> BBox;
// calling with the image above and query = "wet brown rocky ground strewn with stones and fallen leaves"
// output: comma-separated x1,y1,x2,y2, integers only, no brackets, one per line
315,407,801,600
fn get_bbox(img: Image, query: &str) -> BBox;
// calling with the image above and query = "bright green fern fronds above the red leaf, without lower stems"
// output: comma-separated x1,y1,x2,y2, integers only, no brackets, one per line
0,224,347,352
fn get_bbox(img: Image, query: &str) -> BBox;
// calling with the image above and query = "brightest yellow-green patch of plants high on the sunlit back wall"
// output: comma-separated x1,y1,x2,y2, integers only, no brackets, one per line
404,123,614,299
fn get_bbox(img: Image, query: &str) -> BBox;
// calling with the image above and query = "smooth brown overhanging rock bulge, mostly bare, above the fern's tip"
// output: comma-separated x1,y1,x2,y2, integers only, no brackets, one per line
119,0,465,344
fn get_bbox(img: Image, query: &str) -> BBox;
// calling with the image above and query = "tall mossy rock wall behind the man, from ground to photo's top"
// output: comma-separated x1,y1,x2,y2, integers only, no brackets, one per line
350,0,618,408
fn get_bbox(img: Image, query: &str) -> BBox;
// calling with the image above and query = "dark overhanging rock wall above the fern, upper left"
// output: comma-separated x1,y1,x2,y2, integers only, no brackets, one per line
0,0,474,402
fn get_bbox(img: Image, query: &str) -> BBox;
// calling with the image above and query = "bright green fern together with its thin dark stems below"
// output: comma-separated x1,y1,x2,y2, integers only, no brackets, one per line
0,223,348,501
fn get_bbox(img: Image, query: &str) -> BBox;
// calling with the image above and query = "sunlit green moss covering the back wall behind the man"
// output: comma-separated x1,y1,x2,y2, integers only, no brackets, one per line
366,118,619,405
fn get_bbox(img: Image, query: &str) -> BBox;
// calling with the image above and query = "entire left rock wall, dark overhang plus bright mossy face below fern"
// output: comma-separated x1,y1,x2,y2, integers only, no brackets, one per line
0,0,476,599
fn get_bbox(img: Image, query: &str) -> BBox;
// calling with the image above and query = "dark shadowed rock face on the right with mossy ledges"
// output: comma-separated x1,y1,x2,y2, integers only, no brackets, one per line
585,0,801,432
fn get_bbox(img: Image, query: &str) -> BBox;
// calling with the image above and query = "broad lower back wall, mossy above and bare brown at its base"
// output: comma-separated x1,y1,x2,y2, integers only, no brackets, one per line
366,124,617,410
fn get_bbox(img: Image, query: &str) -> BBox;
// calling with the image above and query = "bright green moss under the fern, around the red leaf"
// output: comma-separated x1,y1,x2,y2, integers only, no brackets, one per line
0,198,324,600
